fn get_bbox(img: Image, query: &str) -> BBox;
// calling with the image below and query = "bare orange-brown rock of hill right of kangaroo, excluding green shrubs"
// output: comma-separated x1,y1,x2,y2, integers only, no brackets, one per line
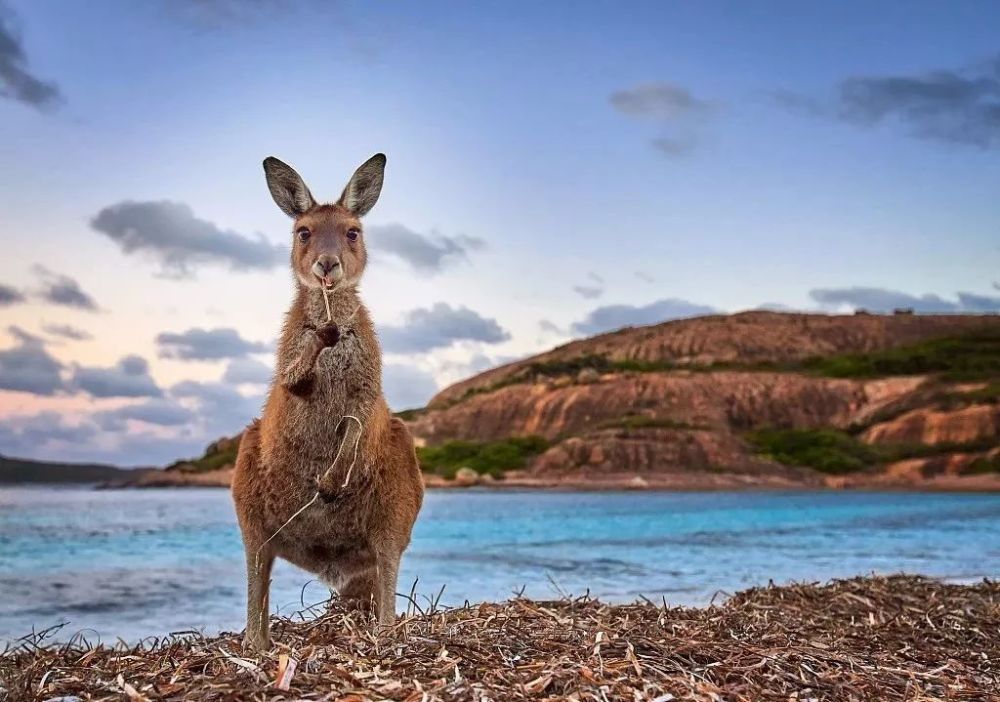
410,312,1000,488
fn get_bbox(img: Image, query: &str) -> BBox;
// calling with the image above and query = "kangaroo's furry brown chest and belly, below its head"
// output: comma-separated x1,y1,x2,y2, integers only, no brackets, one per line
252,291,389,544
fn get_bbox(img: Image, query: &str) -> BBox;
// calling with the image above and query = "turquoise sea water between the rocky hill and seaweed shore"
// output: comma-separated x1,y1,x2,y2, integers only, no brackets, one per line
0,488,1000,642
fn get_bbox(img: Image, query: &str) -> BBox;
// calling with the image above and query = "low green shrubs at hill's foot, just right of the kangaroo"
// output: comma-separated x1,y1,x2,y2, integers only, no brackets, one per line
417,436,549,479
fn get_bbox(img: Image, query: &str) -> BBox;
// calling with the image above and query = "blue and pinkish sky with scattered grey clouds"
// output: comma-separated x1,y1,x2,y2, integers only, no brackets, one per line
0,0,1000,465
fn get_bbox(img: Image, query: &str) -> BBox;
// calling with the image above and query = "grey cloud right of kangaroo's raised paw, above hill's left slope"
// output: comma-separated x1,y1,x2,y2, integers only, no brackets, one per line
379,302,510,353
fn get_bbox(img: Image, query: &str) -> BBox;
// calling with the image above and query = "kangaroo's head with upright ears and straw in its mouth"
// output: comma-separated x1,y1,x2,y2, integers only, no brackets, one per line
264,154,385,290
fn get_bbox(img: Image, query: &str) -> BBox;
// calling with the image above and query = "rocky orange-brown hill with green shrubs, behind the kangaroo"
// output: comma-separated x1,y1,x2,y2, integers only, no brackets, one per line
111,312,1000,490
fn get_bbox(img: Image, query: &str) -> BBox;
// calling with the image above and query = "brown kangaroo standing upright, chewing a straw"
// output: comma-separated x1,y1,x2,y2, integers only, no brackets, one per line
232,154,423,650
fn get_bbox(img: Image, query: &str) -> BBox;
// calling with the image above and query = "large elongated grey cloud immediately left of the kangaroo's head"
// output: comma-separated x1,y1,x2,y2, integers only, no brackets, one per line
90,200,287,278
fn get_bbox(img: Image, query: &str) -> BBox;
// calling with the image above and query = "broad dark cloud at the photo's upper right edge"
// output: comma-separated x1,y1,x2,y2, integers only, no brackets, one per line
773,54,1000,149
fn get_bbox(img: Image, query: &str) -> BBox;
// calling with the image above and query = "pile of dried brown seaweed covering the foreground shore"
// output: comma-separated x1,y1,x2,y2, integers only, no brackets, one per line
0,576,1000,702
